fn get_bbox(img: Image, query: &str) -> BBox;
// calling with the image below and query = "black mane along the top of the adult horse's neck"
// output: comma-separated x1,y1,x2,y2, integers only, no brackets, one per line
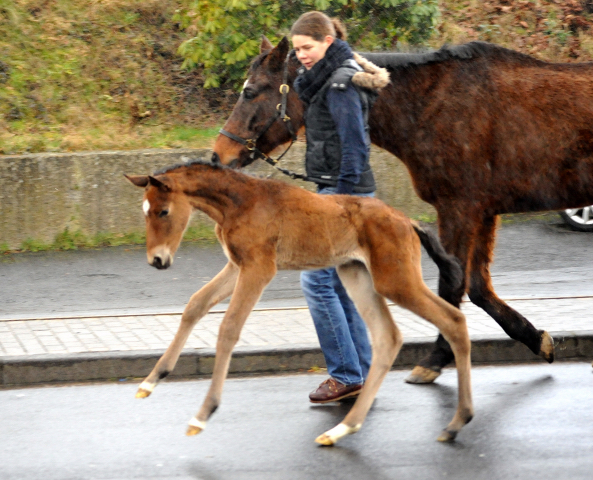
360,42,546,69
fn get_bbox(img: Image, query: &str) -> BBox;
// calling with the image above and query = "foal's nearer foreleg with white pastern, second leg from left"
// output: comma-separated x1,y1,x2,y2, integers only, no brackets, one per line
187,257,276,435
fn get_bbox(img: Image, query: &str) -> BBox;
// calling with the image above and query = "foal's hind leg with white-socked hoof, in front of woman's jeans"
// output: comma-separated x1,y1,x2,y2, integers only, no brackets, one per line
315,262,402,445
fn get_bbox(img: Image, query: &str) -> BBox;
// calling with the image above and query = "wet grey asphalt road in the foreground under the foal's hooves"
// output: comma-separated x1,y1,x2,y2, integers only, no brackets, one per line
0,363,593,480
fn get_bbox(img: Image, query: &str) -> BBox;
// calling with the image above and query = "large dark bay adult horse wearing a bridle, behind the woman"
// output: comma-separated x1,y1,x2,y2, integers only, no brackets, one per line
212,38,593,383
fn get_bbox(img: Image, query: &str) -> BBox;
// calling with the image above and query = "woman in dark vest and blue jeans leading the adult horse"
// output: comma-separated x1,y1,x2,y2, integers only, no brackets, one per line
290,12,389,403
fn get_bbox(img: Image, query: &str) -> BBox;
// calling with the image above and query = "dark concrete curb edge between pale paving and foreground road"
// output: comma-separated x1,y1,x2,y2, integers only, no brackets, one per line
0,331,593,387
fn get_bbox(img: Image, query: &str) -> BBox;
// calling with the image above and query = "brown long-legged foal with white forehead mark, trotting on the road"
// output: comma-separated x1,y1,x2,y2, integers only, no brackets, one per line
126,162,473,445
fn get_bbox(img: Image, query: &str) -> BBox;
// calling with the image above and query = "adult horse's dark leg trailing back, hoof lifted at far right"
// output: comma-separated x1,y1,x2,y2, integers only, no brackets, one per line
468,217,554,363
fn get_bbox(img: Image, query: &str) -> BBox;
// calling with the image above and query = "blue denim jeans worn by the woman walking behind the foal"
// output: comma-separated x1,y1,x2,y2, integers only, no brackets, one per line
301,187,374,385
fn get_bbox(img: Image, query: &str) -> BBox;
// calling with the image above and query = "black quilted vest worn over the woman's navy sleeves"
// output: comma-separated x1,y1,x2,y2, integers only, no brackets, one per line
305,60,377,193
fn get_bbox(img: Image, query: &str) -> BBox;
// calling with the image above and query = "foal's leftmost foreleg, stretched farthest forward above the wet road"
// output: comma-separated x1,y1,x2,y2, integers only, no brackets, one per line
136,262,239,398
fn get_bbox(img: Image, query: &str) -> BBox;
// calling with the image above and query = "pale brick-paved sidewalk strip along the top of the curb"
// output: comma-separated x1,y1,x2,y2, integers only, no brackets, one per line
0,297,593,356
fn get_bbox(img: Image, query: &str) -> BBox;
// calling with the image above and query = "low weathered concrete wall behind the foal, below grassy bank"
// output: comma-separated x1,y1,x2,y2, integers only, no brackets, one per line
0,143,434,248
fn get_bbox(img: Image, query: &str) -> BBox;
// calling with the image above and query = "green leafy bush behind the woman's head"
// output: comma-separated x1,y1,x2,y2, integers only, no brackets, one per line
174,0,439,88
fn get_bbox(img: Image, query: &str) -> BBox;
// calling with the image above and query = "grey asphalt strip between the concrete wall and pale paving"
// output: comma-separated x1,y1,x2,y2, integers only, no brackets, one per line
0,219,593,319
